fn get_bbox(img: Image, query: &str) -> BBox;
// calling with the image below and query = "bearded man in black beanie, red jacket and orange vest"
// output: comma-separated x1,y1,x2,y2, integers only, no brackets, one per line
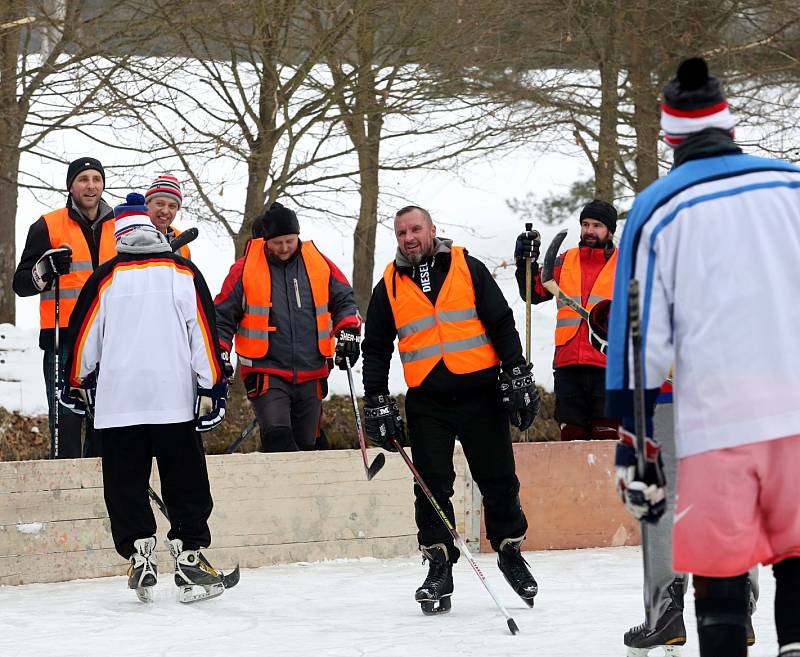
514,200,617,440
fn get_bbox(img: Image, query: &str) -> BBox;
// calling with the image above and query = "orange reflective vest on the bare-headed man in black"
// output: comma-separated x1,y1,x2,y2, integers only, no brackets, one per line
383,246,500,388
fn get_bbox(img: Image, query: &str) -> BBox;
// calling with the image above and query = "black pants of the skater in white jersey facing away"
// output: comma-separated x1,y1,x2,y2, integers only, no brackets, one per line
103,421,213,559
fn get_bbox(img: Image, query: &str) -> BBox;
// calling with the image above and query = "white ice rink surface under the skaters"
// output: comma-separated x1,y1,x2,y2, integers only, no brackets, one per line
0,548,777,657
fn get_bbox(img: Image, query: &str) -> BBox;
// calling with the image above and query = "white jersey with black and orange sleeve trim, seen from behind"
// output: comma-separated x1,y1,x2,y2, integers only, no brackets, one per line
68,253,221,429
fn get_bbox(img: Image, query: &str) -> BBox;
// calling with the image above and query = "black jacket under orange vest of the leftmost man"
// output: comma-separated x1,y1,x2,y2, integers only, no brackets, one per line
13,195,114,349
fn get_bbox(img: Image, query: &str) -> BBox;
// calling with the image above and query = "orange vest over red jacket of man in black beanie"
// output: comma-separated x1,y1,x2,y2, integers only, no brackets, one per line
556,248,617,347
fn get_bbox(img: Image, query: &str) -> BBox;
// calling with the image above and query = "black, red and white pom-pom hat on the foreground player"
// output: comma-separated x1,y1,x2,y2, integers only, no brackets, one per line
661,57,736,148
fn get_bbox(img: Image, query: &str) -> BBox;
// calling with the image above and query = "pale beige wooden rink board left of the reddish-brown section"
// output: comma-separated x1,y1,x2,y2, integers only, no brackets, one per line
0,446,478,584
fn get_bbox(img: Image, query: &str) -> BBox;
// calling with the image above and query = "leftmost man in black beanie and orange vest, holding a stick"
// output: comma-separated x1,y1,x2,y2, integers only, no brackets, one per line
13,157,117,458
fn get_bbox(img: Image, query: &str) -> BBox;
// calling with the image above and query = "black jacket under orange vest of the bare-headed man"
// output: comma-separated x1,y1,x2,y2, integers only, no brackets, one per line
361,239,525,395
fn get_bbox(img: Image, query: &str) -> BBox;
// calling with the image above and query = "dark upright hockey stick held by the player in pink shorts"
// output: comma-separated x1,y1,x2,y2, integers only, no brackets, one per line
628,278,653,629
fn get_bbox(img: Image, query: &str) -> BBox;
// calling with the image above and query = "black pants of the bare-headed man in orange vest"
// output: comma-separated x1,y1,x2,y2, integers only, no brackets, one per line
406,386,528,561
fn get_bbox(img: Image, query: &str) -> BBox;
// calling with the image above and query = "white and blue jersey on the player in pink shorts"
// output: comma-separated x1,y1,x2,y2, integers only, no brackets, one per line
607,155,800,457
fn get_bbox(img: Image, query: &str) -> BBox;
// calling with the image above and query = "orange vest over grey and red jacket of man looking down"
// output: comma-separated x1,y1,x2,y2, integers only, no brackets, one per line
236,238,333,359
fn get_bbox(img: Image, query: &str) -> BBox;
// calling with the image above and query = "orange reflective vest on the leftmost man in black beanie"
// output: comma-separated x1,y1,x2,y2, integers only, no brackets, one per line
39,208,117,329
